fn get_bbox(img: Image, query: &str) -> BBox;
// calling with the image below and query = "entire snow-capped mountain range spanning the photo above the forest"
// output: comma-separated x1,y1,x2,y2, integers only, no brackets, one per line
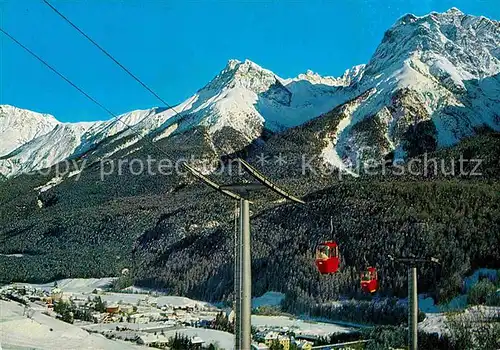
0,8,500,176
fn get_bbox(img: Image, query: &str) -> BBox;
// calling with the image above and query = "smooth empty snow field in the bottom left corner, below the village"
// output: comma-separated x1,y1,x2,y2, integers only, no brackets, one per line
0,300,144,350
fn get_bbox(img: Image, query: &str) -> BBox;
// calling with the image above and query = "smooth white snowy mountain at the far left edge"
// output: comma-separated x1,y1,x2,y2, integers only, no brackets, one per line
0,105,59,156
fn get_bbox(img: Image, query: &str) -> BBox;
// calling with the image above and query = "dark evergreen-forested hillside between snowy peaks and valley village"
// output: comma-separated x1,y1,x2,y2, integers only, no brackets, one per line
0,126,500,311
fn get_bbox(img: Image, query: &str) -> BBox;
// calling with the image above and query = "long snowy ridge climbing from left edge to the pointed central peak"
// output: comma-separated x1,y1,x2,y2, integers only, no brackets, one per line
0,60,354,176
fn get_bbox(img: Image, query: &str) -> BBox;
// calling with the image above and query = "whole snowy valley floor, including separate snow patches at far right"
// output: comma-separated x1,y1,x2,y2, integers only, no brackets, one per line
0,276,500,350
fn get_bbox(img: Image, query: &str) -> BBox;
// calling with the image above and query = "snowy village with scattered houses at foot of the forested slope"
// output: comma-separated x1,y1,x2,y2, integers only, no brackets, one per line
0,278,356,350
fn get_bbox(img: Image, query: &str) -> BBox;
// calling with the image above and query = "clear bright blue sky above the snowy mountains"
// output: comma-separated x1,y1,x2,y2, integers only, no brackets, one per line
0,0,500,122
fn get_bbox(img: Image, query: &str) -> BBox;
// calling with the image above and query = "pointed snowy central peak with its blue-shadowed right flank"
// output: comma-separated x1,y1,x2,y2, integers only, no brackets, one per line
154,60,354,141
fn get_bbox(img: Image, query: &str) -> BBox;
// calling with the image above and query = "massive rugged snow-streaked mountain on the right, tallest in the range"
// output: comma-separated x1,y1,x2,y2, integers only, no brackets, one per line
324,8,500,167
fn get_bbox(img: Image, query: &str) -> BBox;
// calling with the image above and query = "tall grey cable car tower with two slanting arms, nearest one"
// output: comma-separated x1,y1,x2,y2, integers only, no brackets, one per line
183,158,305,350
